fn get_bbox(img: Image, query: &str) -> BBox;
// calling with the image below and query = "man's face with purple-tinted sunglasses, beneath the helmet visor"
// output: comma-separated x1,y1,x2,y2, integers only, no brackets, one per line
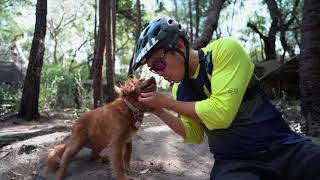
147,49,184,82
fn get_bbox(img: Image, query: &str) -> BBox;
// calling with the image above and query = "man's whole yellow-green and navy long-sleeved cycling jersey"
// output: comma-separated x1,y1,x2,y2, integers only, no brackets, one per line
173,38,306,161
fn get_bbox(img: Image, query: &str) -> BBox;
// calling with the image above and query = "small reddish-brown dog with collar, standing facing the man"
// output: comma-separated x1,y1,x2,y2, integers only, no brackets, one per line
47,78,156,180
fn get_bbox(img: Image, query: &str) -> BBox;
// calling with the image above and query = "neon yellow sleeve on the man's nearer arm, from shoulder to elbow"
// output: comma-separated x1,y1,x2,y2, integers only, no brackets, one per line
195,38,254,130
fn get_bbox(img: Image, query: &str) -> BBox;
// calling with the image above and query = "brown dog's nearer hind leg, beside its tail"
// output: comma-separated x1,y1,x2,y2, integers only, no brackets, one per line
56,137,85,180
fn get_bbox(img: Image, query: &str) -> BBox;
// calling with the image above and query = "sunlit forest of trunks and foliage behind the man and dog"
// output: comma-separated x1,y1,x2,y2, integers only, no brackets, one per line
0,0,320,136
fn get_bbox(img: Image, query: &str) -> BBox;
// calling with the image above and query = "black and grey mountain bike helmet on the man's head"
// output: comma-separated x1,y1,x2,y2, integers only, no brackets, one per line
131,17,189,78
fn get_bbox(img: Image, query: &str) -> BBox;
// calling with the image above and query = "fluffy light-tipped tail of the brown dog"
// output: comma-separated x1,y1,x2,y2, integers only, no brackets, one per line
47,144,66,173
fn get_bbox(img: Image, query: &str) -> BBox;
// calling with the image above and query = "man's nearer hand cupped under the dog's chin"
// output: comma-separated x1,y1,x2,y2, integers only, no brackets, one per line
139,92,172,109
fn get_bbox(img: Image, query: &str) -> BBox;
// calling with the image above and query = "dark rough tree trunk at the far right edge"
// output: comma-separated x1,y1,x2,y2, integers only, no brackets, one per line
299,0,320,137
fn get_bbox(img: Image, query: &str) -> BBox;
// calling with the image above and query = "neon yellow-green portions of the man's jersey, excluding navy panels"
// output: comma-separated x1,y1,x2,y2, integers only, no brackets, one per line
172,38,254,143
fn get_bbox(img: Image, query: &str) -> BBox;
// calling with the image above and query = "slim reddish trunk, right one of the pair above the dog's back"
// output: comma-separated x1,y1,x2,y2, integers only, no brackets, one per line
106,0,116,102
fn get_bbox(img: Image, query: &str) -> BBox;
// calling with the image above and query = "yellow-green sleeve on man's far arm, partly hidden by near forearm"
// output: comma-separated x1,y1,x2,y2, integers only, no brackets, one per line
172,83,204,144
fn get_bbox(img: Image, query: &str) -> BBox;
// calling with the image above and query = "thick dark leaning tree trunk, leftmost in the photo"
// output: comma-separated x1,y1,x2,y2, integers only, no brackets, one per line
19,0,47,120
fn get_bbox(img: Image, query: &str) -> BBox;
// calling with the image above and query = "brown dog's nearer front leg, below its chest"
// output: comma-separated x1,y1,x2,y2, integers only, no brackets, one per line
111,140,129,180
